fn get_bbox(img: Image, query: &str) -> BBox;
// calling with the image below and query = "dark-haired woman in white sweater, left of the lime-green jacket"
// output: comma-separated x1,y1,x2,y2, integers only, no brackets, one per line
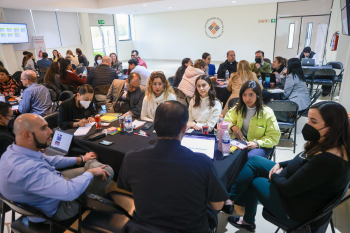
187,75,222,132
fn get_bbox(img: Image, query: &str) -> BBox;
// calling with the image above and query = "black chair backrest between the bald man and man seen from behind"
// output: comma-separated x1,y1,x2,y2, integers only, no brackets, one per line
78,192,133,219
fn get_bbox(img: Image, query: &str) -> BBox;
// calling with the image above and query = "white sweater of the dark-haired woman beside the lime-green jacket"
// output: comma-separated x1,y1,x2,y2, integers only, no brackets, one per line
187,97,222,132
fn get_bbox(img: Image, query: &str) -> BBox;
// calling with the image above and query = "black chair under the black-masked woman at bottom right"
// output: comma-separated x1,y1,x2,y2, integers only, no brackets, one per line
262,182,350,233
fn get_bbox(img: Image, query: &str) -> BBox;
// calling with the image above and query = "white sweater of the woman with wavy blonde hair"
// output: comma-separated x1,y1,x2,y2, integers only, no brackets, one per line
141,92,176,121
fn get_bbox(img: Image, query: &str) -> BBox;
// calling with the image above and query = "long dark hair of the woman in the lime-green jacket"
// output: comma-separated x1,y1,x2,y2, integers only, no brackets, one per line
236,81,264,117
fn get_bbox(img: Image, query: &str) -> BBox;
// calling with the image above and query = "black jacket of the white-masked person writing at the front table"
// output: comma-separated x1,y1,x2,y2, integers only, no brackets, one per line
58,97,96,130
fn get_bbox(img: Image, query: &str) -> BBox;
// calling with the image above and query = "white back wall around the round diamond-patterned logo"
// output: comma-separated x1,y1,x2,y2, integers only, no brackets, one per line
133,3,277,62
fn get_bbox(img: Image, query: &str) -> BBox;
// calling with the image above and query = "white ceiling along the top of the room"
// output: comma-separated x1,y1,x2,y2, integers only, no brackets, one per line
0,0,297,15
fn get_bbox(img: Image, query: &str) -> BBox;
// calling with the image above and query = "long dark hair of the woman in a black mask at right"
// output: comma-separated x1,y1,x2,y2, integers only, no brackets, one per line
304,101,350,166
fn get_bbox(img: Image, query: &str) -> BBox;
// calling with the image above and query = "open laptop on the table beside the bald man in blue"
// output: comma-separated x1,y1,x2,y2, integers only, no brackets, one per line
44,130,73,156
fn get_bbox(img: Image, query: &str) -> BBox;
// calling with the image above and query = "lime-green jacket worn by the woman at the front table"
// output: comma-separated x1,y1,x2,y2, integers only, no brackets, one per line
224,106,281,148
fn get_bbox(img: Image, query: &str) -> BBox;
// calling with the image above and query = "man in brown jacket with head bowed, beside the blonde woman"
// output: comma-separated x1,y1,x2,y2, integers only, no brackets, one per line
106,73,145,118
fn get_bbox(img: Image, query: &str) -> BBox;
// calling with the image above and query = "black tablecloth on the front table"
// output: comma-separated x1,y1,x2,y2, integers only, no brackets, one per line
67,121,248,187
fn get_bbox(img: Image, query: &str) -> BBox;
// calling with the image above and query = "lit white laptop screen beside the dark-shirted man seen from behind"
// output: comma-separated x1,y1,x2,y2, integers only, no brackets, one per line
181,134,215,159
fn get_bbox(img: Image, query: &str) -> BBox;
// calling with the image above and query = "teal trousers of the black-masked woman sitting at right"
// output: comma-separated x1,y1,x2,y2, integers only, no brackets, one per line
230,156,299,227
